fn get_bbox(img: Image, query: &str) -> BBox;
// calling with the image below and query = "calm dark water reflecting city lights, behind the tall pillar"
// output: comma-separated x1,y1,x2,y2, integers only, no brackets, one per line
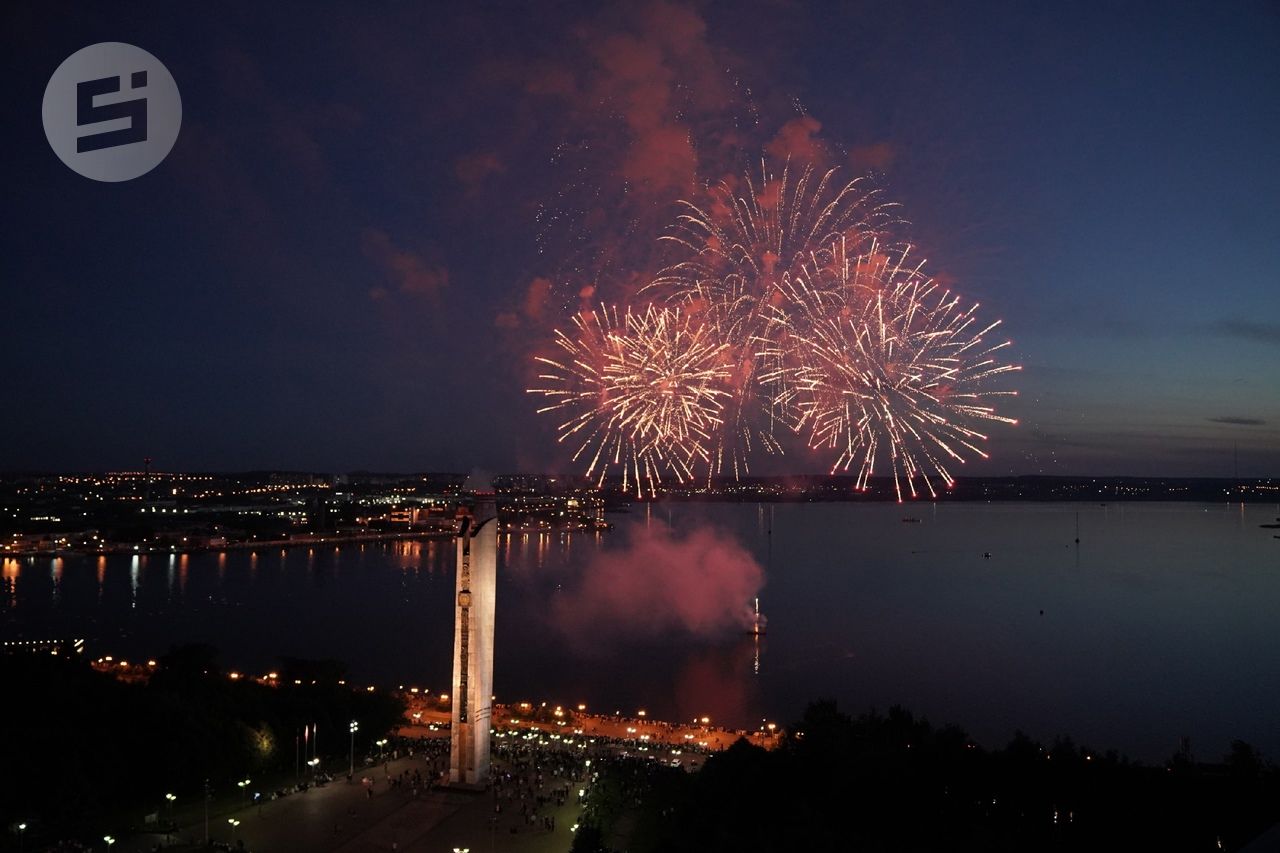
0,503,1280,761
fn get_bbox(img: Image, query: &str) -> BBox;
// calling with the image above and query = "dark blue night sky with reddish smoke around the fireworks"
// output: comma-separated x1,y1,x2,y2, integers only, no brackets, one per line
0,1,1280,476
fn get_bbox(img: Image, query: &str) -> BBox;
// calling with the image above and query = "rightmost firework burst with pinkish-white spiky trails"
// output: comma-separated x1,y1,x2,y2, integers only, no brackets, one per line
776,242,1020,501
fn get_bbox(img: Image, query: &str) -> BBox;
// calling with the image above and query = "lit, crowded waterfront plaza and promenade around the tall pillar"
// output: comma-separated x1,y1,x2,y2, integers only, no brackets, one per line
113,703,777,853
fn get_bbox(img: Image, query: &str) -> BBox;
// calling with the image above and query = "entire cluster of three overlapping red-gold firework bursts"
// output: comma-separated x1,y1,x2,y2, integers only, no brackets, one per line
530,157,1020,501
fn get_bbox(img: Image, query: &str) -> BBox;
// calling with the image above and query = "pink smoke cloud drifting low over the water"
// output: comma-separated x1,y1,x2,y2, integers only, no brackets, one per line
553,520,764,642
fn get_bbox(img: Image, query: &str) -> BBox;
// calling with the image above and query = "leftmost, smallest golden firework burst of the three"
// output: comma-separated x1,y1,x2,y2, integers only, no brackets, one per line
530,306,730,497
